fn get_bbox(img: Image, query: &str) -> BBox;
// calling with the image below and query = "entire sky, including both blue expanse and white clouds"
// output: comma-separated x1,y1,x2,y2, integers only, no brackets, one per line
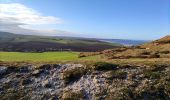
0,0,170,40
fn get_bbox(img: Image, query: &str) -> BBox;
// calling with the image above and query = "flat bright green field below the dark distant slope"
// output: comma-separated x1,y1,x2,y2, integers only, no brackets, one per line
0,52,97,61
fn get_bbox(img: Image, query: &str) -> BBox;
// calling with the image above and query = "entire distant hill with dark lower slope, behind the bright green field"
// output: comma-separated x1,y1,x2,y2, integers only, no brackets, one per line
0,32,121,52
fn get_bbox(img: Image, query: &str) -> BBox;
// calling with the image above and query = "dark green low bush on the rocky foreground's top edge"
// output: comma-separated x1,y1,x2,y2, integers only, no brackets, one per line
93,62,118,71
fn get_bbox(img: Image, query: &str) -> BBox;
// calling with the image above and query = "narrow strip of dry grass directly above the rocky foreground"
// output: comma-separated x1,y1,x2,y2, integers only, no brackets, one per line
0,58,170,67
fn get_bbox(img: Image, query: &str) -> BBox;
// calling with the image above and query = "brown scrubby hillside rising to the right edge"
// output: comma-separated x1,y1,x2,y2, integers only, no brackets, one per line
80,36,170,59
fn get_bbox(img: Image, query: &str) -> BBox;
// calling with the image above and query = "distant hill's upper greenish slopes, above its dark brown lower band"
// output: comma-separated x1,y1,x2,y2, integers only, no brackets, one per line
0,32,121,46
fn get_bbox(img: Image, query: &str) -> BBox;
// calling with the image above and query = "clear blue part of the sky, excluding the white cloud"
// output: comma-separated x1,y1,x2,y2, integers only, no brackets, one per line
0,0,170,40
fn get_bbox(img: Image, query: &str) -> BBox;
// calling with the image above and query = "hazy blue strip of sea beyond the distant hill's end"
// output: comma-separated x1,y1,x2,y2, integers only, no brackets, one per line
101,39,150,46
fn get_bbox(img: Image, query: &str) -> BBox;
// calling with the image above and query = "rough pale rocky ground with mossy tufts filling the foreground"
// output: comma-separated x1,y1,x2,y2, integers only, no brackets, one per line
0,62,170,100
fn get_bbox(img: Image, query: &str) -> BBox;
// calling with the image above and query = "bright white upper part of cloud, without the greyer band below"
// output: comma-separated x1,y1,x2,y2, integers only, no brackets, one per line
0,3,62,25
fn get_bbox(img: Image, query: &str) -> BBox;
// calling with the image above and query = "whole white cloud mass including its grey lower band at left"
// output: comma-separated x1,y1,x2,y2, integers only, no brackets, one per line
0,3,81,36
